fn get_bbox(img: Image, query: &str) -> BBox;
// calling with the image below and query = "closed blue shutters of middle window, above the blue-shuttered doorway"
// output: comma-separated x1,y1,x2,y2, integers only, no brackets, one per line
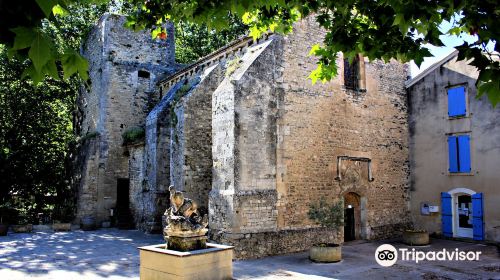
448,135,471,173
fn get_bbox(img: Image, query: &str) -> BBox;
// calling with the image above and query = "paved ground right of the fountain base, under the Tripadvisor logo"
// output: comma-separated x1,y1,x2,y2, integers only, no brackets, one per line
233,239,500,280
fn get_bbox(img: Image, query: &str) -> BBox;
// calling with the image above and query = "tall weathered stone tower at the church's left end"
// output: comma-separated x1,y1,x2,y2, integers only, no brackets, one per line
75,14,177,226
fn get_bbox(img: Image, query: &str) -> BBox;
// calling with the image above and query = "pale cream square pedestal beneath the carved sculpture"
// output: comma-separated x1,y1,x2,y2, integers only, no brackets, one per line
138,243,234,280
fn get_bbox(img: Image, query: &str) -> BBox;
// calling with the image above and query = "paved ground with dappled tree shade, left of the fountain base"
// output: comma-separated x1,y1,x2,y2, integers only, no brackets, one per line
0,229,162,279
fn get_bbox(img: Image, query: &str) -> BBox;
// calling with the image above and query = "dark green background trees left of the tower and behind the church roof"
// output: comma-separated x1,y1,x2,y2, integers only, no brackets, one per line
0,1,246,223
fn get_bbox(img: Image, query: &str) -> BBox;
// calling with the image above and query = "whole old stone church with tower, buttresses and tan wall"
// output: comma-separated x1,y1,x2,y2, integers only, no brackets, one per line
76,15,410,258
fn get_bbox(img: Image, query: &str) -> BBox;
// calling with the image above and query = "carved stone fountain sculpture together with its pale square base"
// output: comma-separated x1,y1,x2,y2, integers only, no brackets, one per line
139,186,233,280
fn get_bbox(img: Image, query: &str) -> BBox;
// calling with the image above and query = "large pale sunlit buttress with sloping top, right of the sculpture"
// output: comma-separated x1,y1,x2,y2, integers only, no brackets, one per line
209,37,280,254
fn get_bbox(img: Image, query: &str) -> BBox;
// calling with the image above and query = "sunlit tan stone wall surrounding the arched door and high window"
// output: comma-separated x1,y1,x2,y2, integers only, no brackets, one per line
277,18,409,239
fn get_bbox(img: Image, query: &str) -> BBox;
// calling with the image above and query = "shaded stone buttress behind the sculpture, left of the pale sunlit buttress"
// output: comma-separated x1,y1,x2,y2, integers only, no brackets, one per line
170,64,224,213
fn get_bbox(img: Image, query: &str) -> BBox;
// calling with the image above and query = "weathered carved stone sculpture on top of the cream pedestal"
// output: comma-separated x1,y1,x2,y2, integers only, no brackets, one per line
163,186,208,252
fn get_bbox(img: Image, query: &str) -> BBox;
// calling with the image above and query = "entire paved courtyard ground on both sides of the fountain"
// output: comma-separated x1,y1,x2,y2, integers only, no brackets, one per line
0,229,500,280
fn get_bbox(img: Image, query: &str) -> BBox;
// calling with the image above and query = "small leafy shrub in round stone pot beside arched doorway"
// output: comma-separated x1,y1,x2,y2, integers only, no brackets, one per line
307,198,344,263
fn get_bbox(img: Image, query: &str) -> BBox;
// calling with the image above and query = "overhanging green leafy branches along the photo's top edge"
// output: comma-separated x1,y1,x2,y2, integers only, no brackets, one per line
0,0,500,105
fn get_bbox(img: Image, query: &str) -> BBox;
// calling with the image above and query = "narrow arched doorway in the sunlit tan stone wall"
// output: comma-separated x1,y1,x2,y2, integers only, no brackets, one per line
344,192,362,241
